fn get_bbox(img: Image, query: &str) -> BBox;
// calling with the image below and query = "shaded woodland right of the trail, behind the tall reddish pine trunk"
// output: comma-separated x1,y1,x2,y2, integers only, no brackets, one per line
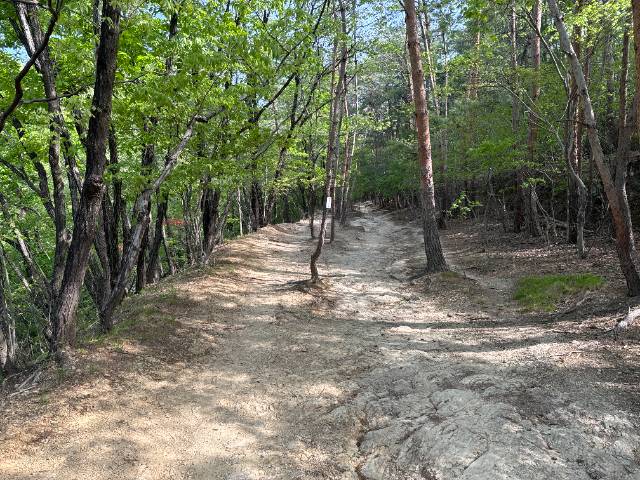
355,0,640,288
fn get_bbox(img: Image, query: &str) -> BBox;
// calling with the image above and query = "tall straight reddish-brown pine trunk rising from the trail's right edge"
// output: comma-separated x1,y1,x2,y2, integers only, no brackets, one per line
405,0,447,272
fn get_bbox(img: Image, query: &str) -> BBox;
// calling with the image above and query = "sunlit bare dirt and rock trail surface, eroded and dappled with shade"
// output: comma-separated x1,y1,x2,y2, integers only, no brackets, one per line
0,205,640,480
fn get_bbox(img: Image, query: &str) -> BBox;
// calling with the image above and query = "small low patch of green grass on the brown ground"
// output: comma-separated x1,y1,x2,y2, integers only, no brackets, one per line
514,273,604,312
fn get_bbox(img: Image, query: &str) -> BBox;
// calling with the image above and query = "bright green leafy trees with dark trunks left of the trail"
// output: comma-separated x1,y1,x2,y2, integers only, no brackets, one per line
0,0,340,370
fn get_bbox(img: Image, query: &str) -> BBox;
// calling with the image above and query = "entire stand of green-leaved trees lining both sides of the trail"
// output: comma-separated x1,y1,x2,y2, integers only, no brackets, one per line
0,0,640,372
